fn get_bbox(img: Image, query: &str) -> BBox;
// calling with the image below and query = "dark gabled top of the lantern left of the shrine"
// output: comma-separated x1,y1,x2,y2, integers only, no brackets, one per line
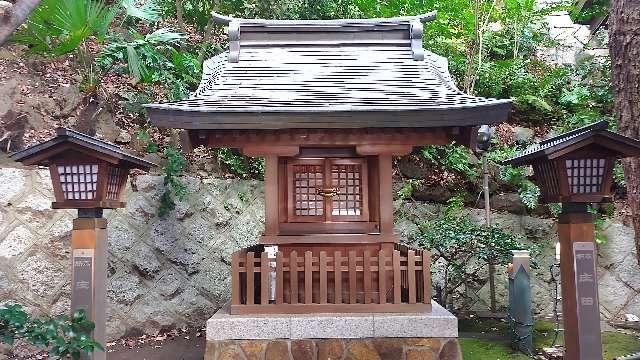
11,128,156,170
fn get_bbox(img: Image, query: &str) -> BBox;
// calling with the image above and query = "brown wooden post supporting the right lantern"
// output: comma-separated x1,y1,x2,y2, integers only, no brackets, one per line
558,204,602,360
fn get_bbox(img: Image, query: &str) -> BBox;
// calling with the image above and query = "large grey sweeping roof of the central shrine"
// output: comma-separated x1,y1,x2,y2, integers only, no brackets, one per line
146,13,511,129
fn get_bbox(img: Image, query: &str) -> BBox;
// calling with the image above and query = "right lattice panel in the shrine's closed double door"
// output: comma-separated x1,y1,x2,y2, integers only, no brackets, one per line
331,164,362,216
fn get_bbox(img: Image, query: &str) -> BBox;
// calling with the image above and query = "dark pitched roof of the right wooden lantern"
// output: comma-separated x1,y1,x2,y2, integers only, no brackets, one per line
503,121,640,166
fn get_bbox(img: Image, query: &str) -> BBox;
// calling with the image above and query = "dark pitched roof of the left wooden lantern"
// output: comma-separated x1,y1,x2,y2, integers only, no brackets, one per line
11,128,156,170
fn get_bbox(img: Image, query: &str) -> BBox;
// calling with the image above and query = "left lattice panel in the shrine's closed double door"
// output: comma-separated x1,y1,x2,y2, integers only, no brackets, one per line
293,165,324,216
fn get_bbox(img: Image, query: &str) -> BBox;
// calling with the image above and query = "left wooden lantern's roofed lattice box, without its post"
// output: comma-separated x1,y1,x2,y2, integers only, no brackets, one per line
12,128,154,209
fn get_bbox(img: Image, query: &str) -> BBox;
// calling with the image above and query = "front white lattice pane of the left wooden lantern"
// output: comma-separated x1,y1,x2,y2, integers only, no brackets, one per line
57,164,98,200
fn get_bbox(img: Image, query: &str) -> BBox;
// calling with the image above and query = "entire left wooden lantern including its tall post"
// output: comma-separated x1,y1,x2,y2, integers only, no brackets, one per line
11,128,155,360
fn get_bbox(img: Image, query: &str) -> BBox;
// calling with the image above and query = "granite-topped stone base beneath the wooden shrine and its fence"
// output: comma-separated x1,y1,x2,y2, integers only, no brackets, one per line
205,303,462,360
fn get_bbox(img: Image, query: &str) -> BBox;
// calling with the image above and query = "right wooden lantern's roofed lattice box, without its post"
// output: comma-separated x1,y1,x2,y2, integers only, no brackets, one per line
505,121,640,203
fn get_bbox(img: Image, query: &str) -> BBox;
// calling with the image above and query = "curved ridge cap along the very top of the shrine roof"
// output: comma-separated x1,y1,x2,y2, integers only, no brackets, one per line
211,11,437,25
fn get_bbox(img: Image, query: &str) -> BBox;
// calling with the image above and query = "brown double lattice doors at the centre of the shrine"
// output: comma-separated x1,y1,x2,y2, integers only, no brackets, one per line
287,159,369,222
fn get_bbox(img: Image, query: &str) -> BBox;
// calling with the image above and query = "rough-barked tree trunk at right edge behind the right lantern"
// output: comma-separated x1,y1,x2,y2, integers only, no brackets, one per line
609,0,640,264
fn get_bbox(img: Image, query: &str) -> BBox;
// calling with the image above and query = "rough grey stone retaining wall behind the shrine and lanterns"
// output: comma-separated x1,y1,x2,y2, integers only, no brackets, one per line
0,165,640,340
